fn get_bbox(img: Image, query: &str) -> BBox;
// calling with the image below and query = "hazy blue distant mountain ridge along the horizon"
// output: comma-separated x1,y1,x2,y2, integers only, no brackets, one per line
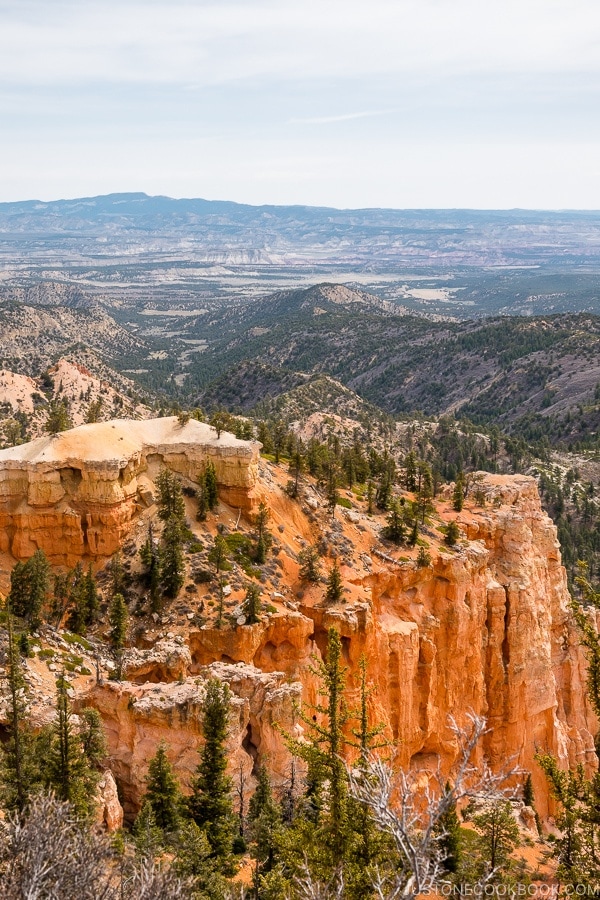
0,193,600,267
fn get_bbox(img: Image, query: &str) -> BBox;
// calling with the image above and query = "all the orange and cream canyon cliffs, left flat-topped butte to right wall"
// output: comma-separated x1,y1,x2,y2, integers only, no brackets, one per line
0,418,598,821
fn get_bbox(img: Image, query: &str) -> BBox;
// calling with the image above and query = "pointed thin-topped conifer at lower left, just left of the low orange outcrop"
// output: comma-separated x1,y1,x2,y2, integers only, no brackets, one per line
46,674,98,816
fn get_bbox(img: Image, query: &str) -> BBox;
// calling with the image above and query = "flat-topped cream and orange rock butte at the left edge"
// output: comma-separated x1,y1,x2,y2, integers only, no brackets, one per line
0,417,260,565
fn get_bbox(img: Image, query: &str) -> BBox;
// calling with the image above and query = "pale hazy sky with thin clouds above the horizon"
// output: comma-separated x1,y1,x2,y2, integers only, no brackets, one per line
0,0,600,209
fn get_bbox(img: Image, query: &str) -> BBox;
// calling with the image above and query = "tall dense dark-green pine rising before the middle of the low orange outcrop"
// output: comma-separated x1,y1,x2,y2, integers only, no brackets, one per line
188,678,235,874
